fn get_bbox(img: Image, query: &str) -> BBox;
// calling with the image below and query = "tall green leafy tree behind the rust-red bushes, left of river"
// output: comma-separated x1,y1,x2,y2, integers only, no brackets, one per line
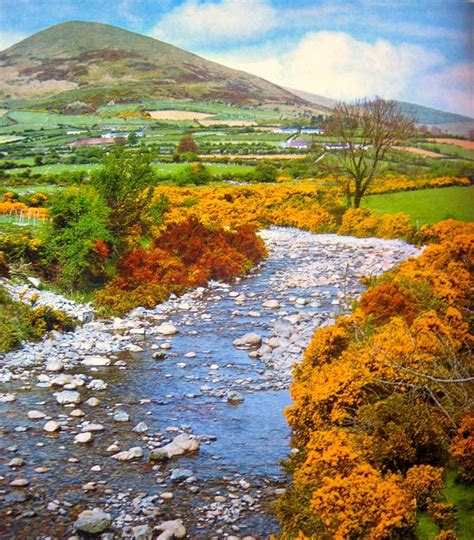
91,148,156,253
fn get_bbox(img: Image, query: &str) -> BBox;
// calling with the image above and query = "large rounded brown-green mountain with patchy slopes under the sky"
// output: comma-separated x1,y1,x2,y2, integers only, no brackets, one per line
0,21,309,108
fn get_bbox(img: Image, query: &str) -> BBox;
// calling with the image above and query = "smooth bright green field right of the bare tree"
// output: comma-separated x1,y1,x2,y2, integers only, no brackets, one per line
362,186,474,225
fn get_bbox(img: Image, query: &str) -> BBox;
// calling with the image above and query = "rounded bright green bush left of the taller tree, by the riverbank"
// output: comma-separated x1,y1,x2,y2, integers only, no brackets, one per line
44,186,110,289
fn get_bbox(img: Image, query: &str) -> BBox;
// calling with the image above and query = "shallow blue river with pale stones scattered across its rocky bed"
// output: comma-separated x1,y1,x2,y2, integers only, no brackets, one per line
0,229,417,540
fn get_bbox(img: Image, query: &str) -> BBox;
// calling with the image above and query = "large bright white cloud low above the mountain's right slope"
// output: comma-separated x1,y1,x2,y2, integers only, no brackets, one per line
208,31,445,99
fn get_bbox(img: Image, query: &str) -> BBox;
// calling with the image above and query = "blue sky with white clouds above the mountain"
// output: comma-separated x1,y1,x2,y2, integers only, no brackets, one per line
0,0,474,117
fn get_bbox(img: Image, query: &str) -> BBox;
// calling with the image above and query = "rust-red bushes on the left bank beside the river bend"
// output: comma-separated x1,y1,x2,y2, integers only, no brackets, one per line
97,216,266,313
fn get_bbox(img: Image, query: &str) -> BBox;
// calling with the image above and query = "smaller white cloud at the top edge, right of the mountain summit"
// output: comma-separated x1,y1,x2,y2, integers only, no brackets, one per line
151,0,278,47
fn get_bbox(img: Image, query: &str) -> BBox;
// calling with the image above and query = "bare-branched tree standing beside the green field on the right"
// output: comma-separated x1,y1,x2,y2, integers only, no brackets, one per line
326,97,415,208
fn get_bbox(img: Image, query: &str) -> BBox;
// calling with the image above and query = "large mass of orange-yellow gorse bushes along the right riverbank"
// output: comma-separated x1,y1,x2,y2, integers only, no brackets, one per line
277,220,474,539
